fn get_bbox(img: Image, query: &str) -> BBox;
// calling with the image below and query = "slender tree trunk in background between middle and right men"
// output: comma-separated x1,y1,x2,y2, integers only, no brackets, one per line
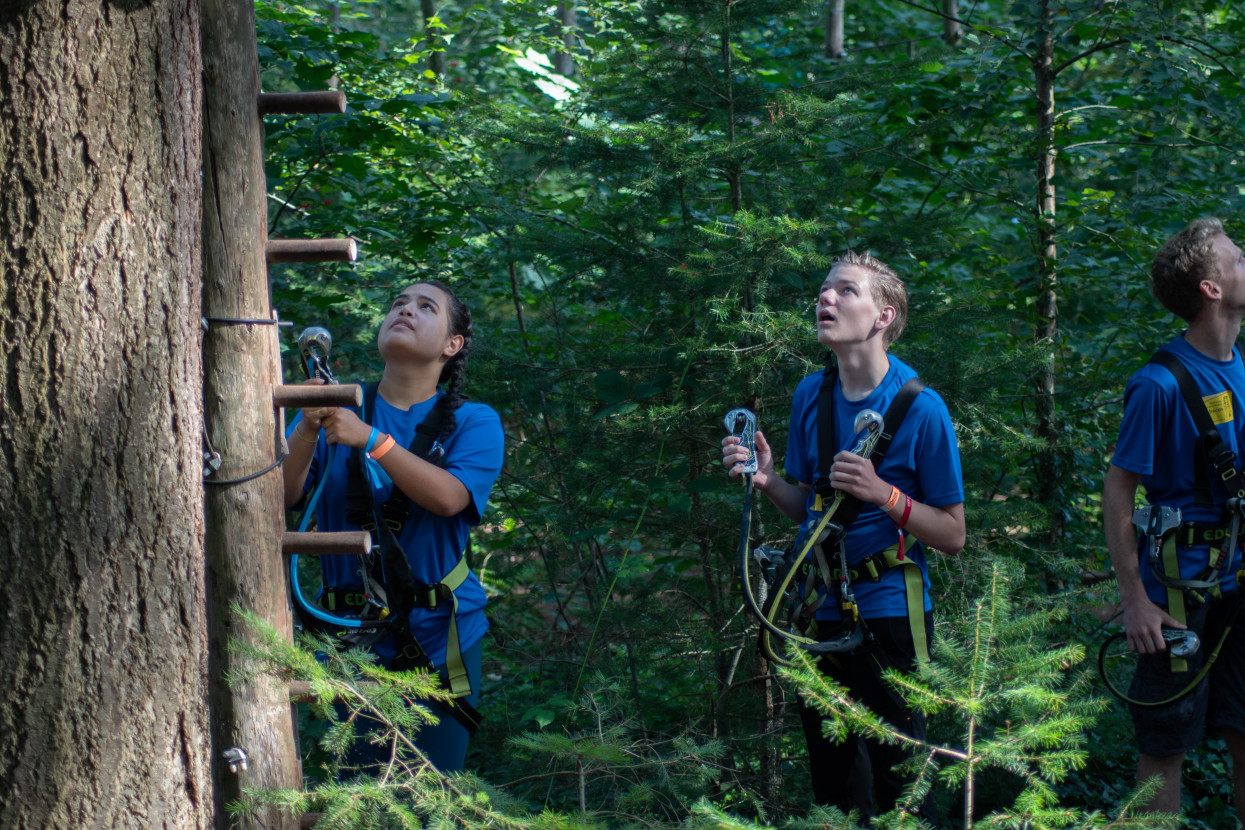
1033,0,1063,546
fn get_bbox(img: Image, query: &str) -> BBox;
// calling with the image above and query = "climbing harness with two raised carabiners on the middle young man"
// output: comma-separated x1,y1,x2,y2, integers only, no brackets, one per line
725,363,929,666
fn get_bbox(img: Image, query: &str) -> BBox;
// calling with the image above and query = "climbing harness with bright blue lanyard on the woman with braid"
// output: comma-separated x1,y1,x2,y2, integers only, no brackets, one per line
289,327,481,734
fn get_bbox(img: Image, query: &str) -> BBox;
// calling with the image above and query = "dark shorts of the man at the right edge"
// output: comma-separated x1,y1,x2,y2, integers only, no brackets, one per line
1128,597,1245,755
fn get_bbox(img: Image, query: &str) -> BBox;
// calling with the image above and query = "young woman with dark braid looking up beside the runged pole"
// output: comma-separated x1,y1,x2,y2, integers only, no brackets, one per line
283,280,503,772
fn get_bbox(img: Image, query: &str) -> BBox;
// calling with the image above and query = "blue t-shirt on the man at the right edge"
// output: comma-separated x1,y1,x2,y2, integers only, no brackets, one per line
1111,333,1245,605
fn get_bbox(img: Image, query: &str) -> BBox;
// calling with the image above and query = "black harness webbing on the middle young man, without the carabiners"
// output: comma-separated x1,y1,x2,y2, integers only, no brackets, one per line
741,356,928,664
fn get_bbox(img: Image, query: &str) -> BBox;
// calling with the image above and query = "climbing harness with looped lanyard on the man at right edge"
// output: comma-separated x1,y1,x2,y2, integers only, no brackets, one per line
1098,350,1245,708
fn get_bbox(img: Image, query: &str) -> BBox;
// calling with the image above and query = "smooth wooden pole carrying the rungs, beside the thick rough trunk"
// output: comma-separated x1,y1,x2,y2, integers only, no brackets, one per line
203,0,303,830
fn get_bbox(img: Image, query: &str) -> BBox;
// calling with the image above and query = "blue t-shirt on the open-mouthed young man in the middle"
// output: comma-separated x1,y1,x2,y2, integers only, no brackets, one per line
787,356,964,620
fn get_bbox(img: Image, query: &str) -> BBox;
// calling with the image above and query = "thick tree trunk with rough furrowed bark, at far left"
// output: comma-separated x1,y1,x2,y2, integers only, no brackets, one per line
0,0,213,830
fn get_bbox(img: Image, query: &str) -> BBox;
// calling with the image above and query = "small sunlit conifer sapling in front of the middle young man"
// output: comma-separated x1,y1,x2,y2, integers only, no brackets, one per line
789,564,1175,830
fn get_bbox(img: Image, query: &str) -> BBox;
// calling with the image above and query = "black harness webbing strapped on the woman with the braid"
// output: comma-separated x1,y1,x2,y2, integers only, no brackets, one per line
346,382,481,734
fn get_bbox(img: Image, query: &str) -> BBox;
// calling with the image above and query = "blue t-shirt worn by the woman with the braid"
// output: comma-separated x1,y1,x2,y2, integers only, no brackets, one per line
289,389,504,666
